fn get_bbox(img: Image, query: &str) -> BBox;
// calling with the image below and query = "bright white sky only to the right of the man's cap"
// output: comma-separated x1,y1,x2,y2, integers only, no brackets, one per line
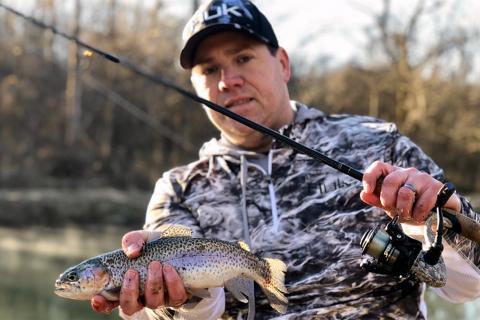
257,0,480,61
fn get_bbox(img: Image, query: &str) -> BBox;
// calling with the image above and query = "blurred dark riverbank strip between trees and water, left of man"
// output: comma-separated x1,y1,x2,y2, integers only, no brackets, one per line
0,188,151,228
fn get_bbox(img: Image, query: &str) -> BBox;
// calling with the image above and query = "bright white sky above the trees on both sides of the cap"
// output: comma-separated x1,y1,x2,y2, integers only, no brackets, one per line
165,0,480,78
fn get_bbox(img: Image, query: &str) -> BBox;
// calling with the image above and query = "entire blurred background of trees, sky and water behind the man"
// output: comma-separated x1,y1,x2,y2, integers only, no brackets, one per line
0,0,480,319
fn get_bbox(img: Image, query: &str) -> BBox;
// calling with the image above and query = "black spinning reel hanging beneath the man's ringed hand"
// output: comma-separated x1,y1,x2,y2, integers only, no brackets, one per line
360,183,455,277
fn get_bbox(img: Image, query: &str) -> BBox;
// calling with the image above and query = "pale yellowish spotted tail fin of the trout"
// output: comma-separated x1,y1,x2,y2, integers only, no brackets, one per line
260,258,288,314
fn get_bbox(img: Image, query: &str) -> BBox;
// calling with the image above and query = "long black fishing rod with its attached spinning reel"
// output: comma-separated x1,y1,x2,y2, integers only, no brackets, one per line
0,2,480,275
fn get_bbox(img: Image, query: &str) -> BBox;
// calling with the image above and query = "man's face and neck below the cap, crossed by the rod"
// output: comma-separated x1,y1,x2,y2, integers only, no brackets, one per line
191,32,293,150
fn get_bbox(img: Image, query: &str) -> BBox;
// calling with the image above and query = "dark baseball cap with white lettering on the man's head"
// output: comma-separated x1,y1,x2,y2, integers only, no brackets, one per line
180,0,278,69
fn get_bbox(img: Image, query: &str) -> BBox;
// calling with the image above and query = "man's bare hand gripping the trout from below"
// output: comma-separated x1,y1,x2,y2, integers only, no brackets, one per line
91,230,188,315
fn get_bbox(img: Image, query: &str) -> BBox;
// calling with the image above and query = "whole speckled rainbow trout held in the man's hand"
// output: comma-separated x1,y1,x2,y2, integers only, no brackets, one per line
55,226,288,319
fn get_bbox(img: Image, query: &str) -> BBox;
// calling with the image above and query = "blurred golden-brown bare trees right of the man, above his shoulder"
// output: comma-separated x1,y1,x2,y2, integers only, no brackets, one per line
294,0,480,191
